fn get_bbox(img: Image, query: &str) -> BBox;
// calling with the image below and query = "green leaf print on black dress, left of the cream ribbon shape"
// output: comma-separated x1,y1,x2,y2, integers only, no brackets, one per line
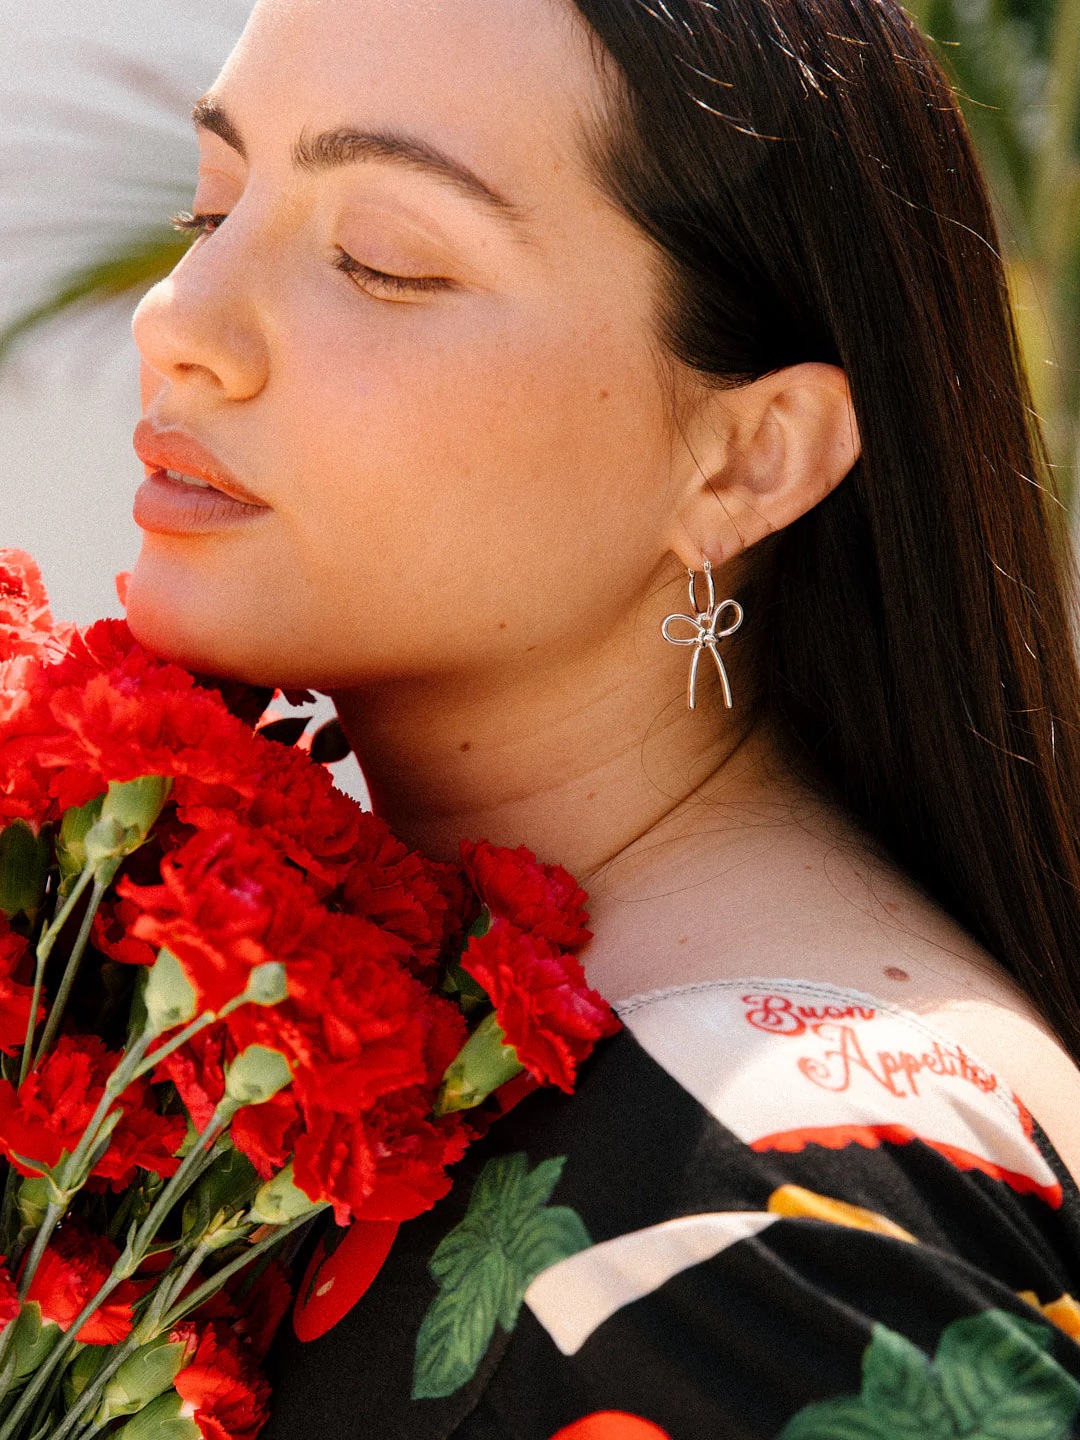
412,1155,592,1400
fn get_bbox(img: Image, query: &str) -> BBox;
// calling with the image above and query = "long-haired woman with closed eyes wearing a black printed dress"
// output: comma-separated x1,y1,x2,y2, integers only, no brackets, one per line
128,0,1080,1440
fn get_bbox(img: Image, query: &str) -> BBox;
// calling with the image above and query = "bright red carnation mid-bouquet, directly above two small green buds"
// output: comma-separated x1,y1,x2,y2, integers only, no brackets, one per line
118,828,321,1011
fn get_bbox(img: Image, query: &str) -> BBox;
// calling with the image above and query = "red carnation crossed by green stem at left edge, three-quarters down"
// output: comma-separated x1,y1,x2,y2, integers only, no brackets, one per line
0,1035,186,1189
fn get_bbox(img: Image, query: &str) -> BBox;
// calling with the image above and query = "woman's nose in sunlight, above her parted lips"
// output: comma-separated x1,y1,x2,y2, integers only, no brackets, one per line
131,226,269,402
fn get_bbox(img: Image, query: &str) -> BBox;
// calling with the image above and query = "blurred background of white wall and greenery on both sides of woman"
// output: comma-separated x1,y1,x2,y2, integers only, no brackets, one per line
0,0,1080,622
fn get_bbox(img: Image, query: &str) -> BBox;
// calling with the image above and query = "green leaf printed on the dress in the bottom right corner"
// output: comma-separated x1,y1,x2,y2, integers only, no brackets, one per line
935,1310,1080,1440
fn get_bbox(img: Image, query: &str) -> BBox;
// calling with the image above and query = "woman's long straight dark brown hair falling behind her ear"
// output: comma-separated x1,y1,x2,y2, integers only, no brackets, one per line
575,0,1080,1060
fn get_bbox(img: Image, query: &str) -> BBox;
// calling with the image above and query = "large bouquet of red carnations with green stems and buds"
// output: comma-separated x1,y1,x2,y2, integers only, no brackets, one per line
0,550,616,1440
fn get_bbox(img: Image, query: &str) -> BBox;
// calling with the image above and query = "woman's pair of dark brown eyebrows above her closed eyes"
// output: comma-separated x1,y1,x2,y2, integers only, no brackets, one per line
192,95,538,222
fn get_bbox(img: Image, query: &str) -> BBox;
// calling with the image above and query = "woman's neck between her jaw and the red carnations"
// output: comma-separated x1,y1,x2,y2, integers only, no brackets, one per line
333,619,789,886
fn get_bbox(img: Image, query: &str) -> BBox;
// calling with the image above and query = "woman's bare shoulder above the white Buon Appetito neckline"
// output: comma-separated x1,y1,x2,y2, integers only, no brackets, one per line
585,789,1080,1179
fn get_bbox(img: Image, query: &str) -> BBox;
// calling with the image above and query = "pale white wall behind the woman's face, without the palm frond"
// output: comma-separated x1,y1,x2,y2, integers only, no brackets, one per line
0,0,249,622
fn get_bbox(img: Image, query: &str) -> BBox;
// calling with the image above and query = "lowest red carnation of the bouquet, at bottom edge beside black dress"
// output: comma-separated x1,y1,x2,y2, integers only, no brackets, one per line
173,1320,269,1440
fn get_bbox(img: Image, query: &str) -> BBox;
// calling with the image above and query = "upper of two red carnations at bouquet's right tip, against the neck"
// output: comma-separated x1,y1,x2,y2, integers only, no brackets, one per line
461,840,592,949
